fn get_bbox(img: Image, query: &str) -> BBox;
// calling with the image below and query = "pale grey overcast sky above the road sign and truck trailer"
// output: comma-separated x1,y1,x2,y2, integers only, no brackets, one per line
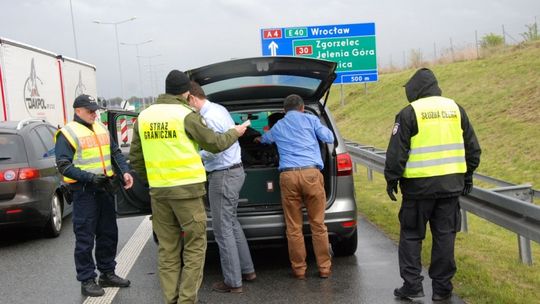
0,0,540,98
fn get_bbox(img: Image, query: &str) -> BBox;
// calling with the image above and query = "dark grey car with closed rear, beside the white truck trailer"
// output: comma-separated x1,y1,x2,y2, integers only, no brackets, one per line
0,119,71,237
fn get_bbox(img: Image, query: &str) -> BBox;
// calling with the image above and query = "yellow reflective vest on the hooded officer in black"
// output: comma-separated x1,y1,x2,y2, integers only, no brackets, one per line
403,96,467,178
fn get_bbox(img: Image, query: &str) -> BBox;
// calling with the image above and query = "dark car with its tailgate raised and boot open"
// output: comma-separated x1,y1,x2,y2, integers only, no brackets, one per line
109,57,357,255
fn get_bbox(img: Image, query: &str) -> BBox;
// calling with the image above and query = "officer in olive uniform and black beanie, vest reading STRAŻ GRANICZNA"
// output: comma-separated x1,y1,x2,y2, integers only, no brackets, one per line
129,70,246,304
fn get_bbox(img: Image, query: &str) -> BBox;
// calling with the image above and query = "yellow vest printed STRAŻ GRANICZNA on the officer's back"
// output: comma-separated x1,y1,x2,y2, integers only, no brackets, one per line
138,104,206,188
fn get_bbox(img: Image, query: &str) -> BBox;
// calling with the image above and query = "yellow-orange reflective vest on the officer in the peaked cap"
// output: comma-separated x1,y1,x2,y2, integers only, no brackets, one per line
55,121,114,184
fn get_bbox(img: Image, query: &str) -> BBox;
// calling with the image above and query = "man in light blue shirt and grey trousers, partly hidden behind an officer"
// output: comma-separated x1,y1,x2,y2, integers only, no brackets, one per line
188,81,257,293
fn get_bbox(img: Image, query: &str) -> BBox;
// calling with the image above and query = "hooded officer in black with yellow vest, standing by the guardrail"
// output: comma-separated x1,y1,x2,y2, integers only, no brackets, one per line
384,68,481,301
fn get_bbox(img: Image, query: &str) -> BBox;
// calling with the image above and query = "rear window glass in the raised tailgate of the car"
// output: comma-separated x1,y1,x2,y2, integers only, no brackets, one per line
202,75,321,95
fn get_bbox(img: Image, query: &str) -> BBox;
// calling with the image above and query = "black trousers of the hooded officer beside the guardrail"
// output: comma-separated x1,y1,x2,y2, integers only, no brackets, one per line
398,197,461,294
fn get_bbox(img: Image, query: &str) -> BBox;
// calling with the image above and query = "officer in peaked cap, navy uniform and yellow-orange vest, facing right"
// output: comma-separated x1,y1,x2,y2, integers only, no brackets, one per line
55,94,133,297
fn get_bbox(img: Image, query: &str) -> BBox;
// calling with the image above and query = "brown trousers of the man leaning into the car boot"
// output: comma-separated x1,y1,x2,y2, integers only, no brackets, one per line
279,169,332,275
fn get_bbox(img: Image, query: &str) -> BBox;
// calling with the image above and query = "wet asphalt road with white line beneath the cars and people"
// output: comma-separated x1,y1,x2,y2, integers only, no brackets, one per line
0,217,463,304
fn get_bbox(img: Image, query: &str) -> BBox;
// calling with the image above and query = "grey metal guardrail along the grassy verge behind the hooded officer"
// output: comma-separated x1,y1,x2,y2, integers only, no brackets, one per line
346,141,540,265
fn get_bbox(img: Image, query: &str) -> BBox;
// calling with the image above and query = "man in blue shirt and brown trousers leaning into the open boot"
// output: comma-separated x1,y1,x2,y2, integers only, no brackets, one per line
260,94,334,280
